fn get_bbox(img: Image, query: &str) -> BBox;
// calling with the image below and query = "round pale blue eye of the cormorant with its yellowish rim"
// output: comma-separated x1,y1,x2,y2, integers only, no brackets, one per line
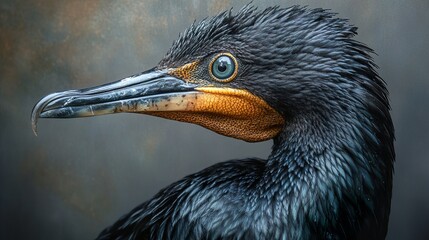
210,53,237,82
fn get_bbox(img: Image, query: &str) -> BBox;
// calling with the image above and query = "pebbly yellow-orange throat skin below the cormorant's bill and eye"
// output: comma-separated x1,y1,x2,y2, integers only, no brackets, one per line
145,87,284,142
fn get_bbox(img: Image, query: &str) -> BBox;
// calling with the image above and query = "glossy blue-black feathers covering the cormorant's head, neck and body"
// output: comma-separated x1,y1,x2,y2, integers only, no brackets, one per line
99,7,394,239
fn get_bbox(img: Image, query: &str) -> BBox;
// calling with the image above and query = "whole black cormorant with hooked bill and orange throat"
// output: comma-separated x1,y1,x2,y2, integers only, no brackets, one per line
32,6,395,239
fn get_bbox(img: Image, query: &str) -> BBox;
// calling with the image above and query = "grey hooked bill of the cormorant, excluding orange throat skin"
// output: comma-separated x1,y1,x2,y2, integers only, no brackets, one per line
31,69,201,135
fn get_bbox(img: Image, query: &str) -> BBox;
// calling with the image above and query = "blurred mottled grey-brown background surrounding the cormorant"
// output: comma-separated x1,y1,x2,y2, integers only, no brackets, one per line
0,0,429,239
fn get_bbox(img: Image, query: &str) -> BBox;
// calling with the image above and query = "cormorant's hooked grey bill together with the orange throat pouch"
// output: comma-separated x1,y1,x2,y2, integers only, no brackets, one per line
31,69,284,142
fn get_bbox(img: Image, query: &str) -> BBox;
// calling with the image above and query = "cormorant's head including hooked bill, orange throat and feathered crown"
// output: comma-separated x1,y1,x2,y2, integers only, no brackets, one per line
32,6,387,146
